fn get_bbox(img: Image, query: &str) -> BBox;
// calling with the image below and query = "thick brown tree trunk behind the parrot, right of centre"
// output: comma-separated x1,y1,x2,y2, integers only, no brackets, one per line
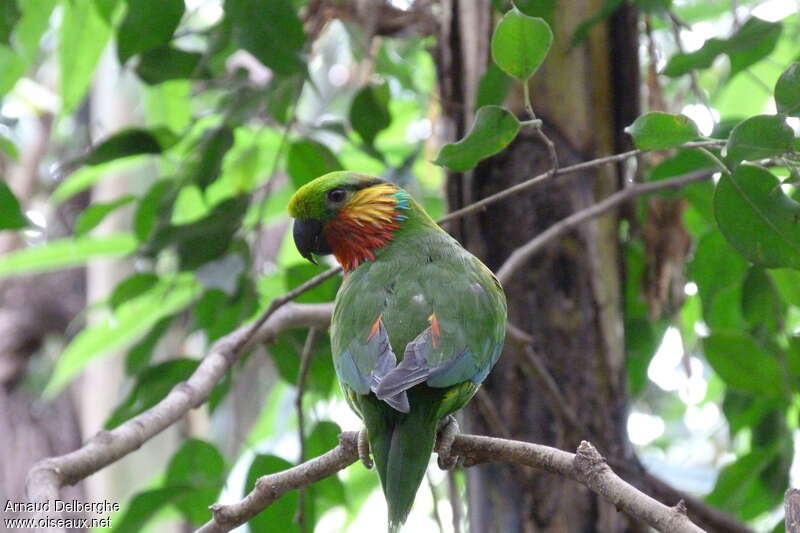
437,0,638,533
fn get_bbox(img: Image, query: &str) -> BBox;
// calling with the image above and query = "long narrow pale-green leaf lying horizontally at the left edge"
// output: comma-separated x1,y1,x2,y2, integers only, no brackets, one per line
0,233,136,279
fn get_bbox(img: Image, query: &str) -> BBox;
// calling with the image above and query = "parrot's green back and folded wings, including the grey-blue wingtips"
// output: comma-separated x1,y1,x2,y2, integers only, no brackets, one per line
331,232,506,412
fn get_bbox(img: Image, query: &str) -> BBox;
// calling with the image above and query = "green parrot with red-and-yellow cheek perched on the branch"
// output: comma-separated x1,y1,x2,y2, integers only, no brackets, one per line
289,172,506,532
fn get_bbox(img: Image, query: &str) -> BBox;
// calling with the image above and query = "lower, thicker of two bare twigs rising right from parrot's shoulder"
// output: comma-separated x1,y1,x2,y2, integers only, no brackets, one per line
497,169,714,285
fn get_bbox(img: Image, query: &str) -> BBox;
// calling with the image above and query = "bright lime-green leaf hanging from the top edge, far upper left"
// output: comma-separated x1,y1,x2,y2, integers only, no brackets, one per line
58,0,111,115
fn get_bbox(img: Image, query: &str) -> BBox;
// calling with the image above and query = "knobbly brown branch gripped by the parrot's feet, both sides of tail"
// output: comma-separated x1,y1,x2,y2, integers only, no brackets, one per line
197,432,703,533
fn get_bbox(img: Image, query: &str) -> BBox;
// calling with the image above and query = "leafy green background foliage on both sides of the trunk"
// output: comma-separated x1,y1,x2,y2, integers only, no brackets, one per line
0,0,800,531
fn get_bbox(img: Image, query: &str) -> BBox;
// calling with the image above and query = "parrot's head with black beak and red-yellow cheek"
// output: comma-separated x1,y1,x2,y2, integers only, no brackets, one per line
289,172,411,271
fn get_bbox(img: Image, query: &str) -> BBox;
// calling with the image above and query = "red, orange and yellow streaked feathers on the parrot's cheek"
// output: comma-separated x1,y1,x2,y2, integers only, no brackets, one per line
324,183,408,272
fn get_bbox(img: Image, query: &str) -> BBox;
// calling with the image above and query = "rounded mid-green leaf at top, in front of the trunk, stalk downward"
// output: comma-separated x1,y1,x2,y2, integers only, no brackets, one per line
492,8,553,81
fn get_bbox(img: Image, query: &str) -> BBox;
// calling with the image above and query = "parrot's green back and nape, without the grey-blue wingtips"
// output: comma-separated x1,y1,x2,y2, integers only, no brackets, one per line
331,197,506,402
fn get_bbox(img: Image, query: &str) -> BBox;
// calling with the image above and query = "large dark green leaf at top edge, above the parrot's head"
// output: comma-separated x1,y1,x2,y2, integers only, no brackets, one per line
225,0,306,76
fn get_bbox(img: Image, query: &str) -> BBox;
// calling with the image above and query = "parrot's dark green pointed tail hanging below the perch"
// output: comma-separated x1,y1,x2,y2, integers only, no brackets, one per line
368,394,439,533
